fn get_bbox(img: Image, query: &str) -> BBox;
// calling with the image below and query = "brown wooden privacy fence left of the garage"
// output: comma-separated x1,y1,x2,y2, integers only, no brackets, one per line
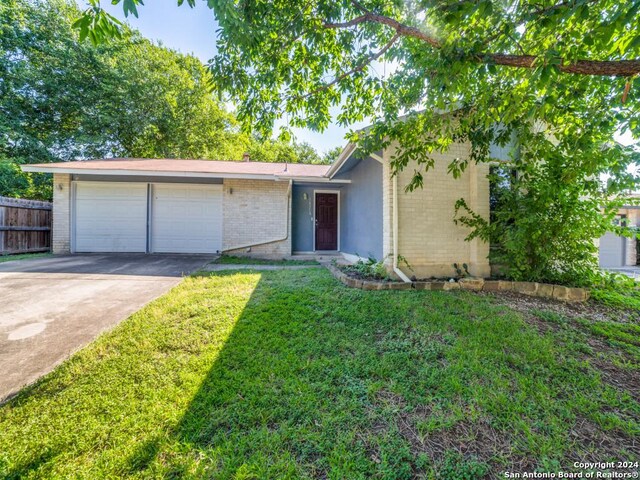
0,197,51,255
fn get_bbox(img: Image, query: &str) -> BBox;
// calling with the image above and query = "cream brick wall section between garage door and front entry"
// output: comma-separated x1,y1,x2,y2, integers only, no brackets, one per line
222,179,291,258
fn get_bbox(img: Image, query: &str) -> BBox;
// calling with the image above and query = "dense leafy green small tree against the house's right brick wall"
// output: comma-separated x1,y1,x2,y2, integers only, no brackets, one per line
456,127,638,285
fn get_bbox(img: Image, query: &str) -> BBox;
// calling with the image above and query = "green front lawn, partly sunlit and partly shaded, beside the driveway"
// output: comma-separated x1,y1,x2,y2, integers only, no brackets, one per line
0,269,640,480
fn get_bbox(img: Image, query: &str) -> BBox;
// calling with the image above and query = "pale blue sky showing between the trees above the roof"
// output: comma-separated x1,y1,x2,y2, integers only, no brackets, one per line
76,0,356,153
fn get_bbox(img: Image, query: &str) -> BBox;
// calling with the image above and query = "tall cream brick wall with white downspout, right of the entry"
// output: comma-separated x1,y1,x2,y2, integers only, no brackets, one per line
383,143,490,278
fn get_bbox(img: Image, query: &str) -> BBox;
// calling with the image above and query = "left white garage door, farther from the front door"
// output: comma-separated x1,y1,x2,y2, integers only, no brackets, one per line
74,182,147,252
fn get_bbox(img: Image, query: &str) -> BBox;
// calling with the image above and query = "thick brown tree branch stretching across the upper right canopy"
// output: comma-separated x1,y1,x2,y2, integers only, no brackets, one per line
323,7,640,77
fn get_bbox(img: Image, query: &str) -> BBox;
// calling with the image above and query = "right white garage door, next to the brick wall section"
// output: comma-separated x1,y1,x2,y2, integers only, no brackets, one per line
151,184,222,253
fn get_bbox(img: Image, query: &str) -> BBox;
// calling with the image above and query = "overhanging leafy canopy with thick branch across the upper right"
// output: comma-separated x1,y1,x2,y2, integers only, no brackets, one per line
76,0,640,193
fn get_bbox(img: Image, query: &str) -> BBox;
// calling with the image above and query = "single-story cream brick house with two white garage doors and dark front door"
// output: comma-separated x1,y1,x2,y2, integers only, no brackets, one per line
23,143,490,278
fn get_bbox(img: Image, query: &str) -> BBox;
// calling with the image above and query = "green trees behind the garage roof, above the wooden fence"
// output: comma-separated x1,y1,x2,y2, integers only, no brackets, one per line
0,0,330,199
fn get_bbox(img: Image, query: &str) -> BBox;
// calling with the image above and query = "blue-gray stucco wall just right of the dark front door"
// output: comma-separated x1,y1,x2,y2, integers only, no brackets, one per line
340,158,383,260
